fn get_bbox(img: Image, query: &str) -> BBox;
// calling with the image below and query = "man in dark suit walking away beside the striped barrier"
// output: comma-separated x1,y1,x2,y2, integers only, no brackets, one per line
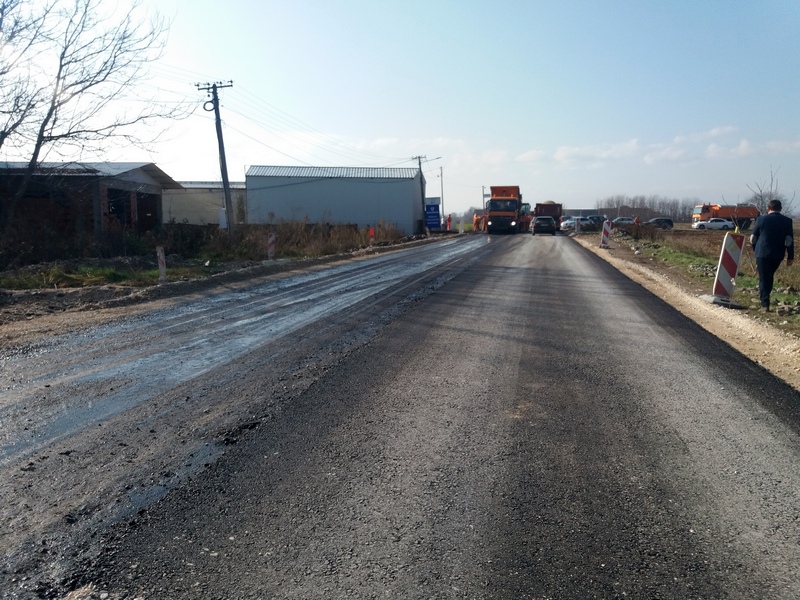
750,200,794,311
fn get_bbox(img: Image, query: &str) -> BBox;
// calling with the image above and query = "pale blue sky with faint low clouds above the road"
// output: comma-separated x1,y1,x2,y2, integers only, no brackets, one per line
70,0,800,213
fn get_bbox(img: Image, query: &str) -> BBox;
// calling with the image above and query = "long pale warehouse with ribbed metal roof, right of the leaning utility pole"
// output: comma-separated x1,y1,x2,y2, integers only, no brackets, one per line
245,166,425,235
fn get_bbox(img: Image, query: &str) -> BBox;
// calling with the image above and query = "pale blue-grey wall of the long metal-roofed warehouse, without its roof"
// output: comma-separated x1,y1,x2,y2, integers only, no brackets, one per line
246,175,423,234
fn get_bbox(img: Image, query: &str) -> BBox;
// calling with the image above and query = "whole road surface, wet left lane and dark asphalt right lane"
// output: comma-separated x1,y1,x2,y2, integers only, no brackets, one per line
0,235,800,599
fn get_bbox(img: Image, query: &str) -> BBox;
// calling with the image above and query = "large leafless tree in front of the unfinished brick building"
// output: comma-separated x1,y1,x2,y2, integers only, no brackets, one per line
0,0,186,235
